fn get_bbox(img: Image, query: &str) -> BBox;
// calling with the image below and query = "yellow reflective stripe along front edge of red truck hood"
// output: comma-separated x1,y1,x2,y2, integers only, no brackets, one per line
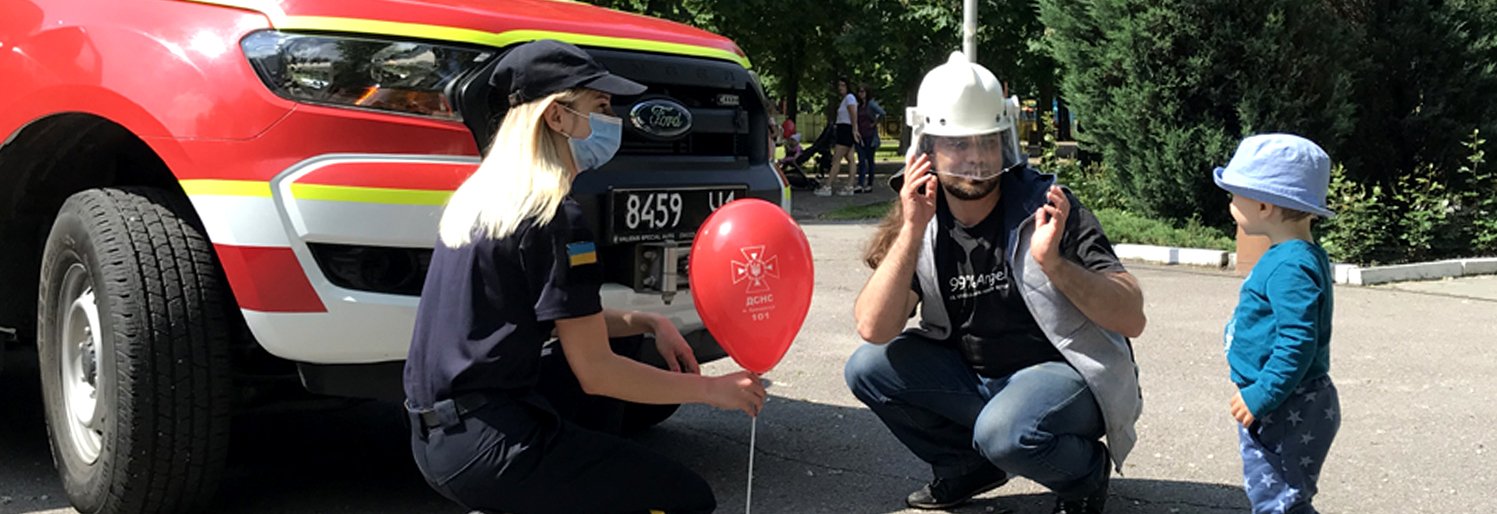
272,16,750,69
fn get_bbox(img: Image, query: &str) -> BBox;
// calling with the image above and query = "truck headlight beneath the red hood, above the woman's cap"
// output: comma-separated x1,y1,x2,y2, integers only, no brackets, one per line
240,30,493,120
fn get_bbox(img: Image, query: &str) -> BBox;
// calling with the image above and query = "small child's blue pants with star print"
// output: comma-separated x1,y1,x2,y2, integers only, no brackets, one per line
1238,376,1341,514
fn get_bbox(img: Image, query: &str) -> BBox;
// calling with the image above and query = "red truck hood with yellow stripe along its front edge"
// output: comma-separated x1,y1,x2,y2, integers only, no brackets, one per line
196,0,749,67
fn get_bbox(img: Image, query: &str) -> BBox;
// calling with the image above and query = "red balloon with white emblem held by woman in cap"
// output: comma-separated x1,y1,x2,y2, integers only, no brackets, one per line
687,198,816,373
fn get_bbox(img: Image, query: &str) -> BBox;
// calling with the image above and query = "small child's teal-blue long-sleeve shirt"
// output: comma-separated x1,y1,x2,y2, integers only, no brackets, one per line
1223,240,1334,417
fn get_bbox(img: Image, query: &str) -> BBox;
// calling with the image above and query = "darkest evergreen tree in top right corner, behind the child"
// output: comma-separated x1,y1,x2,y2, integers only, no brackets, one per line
1338,0,1497,186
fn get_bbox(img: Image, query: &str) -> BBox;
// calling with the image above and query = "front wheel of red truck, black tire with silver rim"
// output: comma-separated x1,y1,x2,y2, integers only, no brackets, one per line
37,187,231,514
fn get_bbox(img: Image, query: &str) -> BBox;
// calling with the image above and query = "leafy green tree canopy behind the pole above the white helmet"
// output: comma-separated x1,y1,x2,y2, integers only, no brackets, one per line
593,0,1055,149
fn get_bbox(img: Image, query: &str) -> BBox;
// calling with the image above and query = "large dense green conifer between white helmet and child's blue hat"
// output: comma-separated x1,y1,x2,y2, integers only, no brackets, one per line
1039,0,1358,226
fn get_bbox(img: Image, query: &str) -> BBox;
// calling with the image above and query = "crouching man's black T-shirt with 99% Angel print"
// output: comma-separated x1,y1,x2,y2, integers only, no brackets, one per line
915,181,1126,376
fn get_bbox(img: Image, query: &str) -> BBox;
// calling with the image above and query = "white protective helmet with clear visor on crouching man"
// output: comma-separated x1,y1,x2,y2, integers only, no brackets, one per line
906,51,1024,180
